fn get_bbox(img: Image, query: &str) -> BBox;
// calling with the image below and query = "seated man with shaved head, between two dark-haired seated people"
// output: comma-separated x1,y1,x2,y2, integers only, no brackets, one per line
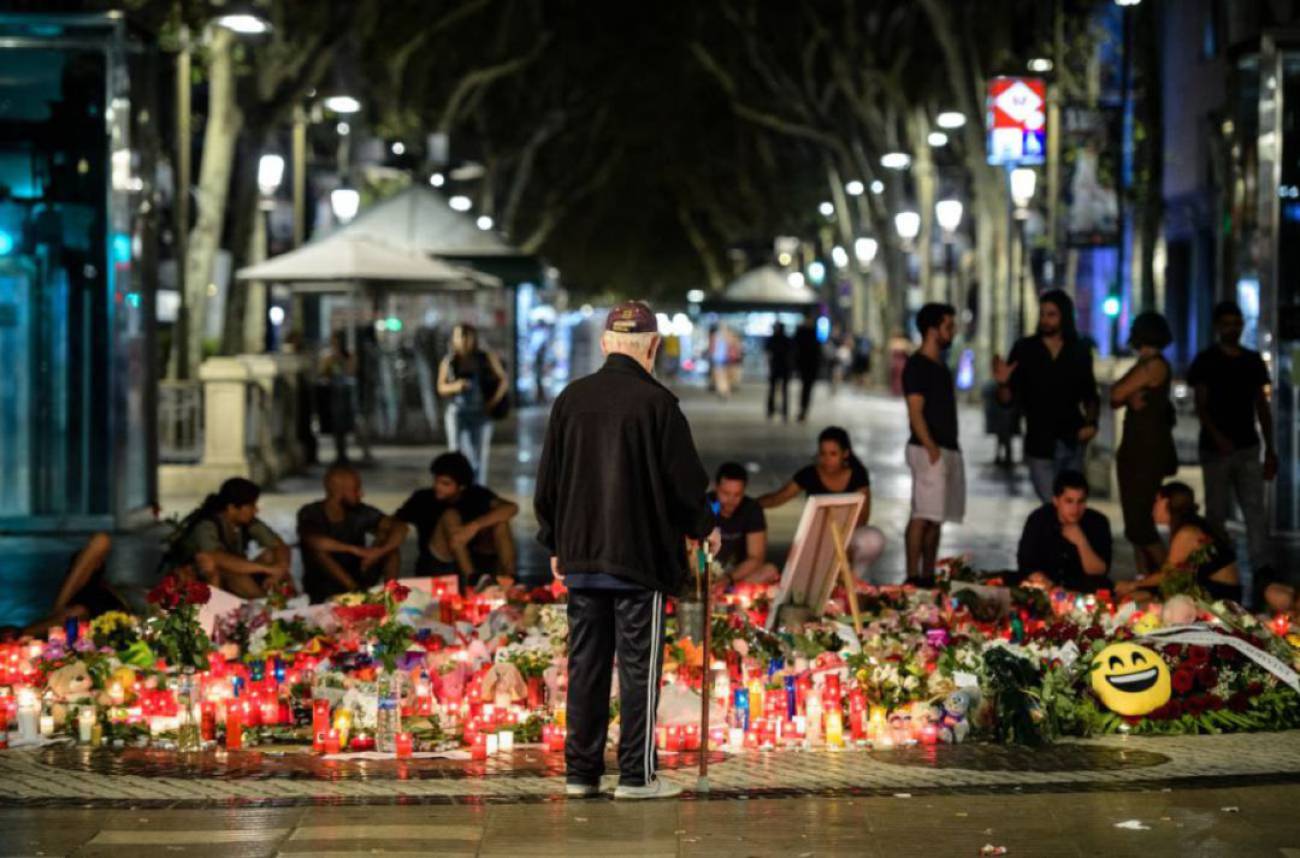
298,463,407,603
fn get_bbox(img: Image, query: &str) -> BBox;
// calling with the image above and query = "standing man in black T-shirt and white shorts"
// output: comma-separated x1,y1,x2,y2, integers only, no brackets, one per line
902,304,966,585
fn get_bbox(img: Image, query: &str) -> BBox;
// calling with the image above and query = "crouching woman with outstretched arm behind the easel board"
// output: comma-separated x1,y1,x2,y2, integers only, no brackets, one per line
758,426,894,584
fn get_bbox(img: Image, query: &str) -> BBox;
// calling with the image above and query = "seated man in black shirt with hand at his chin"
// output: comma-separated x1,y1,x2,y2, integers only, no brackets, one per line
1017,471,1112,593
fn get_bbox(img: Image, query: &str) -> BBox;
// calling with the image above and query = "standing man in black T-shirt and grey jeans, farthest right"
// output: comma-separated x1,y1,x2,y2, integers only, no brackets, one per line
1187,302,1278,597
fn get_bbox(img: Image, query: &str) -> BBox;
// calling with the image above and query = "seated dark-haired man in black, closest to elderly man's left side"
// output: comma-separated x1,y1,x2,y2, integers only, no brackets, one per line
397,452,519,589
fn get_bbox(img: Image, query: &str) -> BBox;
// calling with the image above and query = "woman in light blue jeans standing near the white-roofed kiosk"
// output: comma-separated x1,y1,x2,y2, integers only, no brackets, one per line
438,324,510,485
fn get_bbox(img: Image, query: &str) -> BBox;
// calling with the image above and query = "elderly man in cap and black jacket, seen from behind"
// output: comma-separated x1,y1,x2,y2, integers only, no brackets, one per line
533,302,718,798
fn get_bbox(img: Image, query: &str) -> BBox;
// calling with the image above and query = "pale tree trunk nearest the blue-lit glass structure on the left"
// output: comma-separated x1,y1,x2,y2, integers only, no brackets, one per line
184,27,243,374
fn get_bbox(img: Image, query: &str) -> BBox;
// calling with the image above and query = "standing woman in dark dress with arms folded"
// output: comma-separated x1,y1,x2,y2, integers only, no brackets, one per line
1110,312,1178,575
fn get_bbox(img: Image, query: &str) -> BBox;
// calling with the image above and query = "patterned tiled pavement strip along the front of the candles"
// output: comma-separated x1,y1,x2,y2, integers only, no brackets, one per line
0,731,1300,807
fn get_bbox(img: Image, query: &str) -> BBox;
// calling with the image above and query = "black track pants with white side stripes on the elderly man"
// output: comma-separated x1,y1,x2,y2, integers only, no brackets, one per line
564,590,663,787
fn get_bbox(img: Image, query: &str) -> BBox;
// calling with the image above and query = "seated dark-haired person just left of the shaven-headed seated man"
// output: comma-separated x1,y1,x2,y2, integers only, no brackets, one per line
164,477,293,599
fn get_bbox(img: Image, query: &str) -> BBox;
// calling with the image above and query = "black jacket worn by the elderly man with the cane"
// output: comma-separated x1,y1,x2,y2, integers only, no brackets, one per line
533,355,712,592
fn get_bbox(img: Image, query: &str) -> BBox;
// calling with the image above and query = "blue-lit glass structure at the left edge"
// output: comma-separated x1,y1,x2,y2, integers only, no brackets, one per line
0,14,156,532
